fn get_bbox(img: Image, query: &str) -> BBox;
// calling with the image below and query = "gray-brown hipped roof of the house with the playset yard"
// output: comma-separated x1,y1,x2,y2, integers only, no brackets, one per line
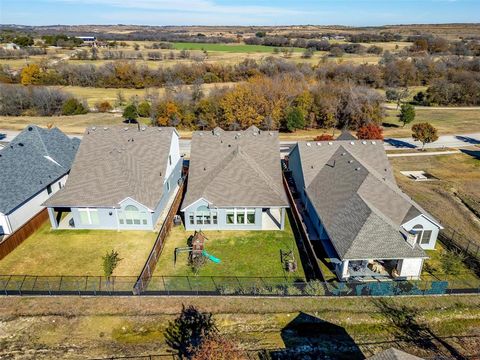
182,126,288,209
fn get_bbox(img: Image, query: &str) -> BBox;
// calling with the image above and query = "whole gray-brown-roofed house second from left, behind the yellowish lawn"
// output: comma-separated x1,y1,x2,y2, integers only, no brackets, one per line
45,126,183,230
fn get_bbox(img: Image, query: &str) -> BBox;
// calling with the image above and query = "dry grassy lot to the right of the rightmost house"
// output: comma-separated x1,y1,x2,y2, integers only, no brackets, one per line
390,148,480,244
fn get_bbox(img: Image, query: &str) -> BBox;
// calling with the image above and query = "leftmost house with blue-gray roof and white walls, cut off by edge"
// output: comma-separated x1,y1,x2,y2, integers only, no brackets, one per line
0,125,80,238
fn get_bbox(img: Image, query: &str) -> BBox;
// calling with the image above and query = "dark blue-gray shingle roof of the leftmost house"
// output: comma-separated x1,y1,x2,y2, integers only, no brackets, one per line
0,125,80,214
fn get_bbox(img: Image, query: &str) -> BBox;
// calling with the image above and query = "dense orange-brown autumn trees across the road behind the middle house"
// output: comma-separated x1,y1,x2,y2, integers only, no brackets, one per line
151,75,384,131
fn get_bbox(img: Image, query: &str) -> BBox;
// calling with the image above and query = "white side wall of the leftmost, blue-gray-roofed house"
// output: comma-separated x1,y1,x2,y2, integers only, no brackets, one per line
7,175,67,232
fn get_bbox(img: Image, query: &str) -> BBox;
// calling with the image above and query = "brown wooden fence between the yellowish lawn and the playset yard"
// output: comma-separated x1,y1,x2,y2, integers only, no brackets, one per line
133,177,186,295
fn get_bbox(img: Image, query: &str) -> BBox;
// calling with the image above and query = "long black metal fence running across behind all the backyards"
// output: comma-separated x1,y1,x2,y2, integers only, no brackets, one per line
0,275,480,297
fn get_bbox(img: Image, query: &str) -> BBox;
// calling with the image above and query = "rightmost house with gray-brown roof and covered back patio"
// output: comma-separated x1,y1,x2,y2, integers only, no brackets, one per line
289,139,442,280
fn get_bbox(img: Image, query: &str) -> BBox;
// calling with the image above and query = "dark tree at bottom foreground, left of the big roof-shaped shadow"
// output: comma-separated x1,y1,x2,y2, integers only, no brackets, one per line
165,305,218,358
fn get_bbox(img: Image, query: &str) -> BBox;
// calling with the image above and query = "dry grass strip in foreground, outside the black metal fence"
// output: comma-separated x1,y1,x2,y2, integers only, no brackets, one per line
0,296,480,359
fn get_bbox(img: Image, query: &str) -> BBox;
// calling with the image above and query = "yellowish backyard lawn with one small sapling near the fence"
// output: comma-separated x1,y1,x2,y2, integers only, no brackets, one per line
0,222,156,276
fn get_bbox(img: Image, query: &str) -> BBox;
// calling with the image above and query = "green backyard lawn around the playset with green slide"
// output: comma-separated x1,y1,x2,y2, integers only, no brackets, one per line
154,215,305,279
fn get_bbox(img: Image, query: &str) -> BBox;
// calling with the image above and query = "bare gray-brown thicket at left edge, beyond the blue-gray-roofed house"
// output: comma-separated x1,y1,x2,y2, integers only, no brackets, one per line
0,85,88,116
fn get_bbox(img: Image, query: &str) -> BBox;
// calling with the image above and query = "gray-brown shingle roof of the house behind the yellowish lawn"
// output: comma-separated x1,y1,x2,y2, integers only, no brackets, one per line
45,126,177,210
